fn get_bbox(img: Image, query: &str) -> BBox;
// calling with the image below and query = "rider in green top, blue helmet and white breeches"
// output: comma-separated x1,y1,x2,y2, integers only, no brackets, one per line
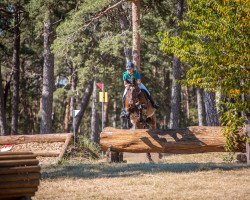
122,61,159,109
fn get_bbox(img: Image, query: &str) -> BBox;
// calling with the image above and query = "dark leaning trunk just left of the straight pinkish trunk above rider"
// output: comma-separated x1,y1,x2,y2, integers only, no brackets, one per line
118,4,131,62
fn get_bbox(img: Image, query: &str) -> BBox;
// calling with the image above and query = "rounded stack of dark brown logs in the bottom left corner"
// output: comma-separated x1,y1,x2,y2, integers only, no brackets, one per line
0,152,41,199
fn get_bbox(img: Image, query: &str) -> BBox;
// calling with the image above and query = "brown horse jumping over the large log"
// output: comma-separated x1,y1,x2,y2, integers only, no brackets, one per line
122,76,162,162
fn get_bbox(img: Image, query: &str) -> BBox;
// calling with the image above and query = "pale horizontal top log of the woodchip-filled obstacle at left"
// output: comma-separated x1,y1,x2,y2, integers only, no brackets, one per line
0,133,73,145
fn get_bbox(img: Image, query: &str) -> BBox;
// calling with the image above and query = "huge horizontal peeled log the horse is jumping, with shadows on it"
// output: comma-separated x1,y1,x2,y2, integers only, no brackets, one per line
100,126,229,154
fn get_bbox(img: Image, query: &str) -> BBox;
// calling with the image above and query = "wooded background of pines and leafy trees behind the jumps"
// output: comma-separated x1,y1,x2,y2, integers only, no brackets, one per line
0,0,250,151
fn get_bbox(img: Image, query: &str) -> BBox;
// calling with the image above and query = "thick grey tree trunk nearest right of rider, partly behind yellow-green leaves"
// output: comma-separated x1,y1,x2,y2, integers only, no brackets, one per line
170,0,184,128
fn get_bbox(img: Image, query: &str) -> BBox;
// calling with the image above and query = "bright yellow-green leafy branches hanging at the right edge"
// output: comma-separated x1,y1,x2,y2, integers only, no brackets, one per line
159,0,250,151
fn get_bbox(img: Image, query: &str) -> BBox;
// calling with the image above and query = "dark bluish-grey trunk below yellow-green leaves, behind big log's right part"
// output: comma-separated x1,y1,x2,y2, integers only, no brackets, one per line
204,91,219,126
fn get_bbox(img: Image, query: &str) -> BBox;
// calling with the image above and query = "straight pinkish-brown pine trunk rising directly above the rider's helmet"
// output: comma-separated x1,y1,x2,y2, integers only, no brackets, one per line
132,0,141,72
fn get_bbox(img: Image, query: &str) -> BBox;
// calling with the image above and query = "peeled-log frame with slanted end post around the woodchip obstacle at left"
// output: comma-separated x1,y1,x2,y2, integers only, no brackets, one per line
0,133,73,163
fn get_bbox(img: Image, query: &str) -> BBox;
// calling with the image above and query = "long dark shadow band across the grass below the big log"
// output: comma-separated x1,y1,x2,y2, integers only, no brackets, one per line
42,163,250,179
